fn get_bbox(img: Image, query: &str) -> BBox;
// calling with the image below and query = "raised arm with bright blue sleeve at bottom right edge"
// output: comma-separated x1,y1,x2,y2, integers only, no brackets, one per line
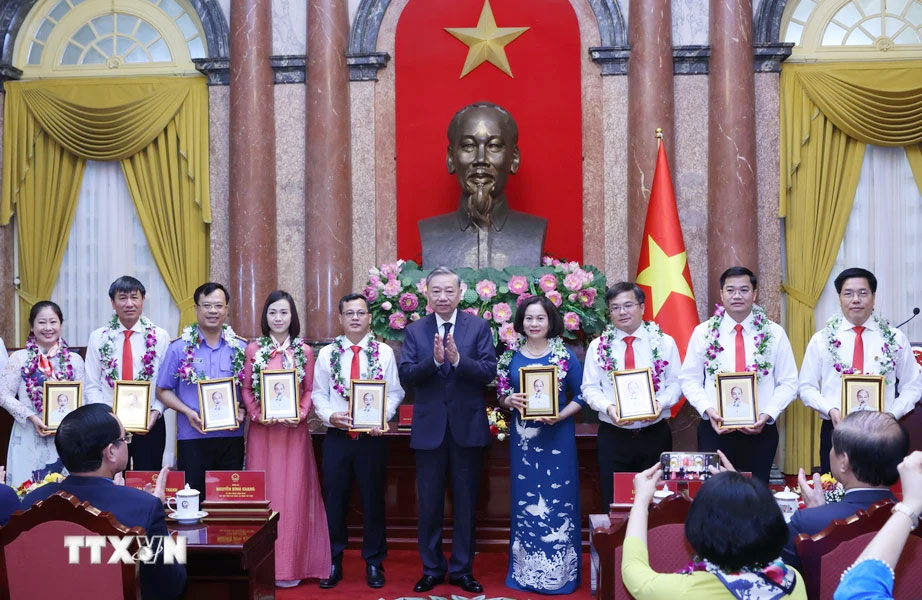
833,451,922,600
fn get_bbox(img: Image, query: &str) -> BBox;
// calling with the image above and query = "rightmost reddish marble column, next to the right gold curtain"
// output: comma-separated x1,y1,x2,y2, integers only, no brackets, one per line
708,0,759,306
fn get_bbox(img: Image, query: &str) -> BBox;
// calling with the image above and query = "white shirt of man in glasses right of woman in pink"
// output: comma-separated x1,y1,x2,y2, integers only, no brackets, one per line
311,333,404,427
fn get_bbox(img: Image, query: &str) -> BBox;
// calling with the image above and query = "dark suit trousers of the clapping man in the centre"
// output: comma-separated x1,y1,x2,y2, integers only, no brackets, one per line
416,431,483,577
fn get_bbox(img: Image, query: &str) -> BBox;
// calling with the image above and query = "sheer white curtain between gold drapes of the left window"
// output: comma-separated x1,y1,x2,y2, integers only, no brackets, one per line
51,161,179,465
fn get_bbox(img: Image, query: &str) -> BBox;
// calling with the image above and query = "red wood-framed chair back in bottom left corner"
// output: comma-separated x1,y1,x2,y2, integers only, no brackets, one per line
0,491,144,600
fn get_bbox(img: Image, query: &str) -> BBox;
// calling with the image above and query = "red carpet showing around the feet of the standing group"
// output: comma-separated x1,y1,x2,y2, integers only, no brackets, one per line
276,550,593,600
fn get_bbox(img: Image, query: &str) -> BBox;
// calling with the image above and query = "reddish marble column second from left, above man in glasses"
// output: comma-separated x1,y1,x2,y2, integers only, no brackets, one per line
301,0,352,340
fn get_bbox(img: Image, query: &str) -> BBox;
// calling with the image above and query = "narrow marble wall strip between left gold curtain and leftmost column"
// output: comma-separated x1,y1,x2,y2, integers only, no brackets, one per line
208,85,230,282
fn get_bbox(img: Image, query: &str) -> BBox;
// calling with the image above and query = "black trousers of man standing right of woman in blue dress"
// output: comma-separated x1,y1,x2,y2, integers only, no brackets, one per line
596,420,672,509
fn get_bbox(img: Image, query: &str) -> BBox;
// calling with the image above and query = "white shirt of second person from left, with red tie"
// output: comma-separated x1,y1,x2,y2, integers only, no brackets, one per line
83,319,170,415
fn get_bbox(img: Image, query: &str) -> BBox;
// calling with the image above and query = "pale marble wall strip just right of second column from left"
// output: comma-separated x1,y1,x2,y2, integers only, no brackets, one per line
349,81,377,290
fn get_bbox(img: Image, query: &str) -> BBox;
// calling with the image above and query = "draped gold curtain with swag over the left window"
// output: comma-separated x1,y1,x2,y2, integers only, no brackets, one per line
0,77,211,338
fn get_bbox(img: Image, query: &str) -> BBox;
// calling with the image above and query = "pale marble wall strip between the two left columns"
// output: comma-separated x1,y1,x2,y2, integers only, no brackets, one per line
274,85,311,322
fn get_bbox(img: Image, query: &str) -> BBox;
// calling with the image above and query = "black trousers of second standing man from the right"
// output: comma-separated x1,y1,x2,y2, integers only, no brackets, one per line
698,419,778,483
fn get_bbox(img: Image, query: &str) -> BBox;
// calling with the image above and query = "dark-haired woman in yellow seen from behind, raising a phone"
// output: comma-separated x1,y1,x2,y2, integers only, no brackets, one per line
621,465,807,600
